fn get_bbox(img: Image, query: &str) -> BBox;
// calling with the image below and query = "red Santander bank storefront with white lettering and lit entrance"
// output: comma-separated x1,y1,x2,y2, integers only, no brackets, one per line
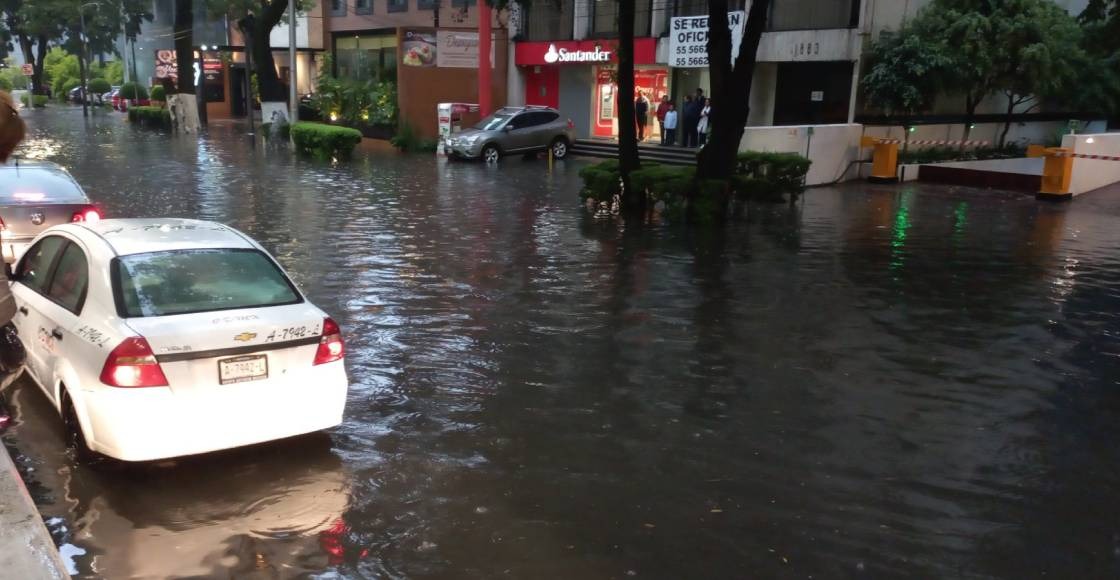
514,38,670,141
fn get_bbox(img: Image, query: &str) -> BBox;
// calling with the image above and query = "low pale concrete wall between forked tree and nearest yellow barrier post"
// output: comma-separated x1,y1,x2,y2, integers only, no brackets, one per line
739,124,864,186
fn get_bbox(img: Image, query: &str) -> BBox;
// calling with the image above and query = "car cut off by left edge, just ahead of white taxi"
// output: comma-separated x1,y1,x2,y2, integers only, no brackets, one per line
0,159,101,263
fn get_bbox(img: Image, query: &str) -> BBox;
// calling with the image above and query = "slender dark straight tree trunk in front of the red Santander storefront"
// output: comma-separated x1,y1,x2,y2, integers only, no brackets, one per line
615,0,645,215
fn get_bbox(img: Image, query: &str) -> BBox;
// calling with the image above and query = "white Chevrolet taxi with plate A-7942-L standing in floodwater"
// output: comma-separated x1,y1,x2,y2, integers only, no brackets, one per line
11,219,348,461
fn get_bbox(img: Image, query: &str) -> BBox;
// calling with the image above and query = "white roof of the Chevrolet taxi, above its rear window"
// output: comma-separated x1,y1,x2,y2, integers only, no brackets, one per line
78,218,254,255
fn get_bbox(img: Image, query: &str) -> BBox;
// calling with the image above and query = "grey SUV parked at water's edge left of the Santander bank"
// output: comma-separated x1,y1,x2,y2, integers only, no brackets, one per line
444,106,575,163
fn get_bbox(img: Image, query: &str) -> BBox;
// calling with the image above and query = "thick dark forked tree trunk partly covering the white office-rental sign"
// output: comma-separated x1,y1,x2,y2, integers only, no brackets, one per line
697,0,771,179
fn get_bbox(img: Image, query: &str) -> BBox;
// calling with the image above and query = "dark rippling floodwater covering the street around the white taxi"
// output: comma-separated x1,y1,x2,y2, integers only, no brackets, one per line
4,110,1120,579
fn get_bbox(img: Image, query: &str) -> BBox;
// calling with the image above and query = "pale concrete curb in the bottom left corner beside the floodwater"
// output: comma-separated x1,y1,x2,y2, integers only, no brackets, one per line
0,445,69,580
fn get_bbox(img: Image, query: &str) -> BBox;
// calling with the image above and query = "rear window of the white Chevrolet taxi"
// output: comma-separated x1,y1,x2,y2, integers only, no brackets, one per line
112,249,302,318
